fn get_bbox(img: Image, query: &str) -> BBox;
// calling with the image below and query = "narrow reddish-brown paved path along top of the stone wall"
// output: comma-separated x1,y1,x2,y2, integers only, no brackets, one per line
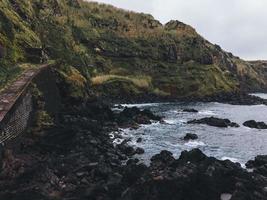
0,64,49,123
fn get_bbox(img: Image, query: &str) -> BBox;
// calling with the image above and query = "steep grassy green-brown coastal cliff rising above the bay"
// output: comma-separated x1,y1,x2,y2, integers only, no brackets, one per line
0,0,267,100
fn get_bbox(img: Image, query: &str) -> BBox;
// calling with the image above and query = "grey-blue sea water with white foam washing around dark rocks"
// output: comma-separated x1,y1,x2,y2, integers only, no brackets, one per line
112,94,267,165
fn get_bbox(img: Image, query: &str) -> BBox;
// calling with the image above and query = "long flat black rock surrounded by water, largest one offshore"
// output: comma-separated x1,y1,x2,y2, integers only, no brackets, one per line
187,117,239,128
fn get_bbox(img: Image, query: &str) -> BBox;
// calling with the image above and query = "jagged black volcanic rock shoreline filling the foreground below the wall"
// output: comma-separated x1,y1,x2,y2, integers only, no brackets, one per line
0,103,267,200
